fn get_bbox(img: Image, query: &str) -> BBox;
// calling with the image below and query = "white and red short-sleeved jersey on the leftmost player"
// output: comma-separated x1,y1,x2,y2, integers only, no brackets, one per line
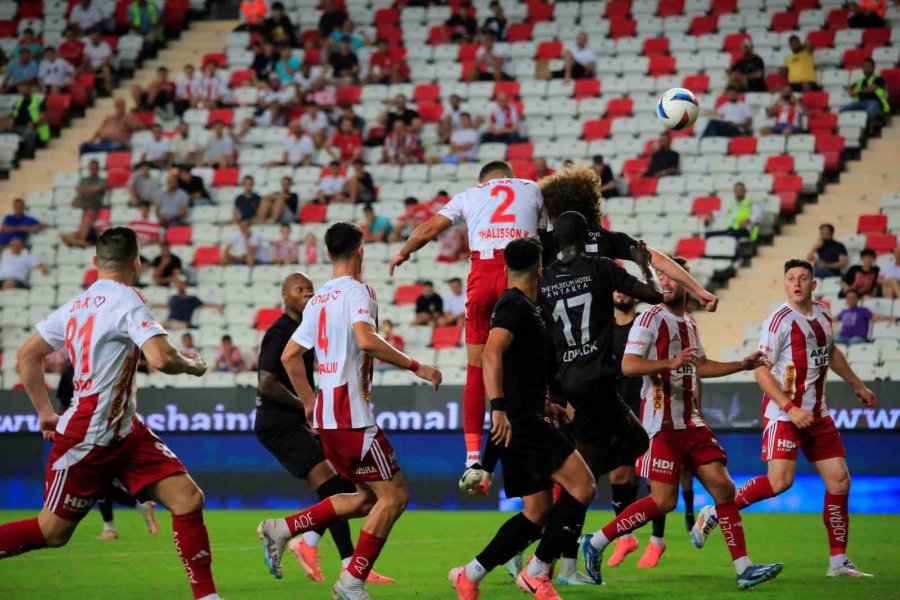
36,279,166,469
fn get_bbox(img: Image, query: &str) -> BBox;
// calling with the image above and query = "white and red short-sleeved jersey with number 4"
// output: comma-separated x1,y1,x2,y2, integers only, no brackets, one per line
291,276,378,429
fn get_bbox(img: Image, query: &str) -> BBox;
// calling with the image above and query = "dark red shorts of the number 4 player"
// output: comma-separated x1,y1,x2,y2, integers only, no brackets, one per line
319,425,400,483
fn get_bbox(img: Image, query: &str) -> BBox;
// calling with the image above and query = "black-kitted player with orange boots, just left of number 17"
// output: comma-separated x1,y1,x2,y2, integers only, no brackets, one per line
448,238,597,600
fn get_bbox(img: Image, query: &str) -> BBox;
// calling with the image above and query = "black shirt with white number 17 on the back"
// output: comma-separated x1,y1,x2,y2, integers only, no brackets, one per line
541,254,637,393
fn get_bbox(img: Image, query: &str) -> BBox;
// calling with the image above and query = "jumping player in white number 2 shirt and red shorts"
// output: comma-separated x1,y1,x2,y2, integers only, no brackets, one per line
389,161,545,490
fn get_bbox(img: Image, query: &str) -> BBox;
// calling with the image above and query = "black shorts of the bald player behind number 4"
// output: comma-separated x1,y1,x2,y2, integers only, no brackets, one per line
255,409,325,479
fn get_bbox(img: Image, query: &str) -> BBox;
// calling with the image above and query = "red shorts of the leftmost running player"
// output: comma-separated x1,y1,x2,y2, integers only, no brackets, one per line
44,419,187,521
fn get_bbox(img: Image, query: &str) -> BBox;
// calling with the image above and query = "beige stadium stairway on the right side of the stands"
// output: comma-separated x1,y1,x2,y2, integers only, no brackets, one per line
695,119,900,359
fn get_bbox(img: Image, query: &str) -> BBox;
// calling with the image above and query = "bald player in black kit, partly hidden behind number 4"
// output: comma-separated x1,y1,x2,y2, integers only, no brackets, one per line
256,273,394,583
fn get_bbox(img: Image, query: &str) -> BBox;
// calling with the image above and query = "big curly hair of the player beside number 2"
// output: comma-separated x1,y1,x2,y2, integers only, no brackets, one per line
538,165,603,228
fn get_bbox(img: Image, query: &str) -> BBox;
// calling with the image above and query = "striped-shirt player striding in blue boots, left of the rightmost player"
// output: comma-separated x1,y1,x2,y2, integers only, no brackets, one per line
581,258,782,589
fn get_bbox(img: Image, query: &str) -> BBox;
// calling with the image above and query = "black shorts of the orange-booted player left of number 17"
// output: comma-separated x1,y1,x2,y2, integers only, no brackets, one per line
500,415,575,498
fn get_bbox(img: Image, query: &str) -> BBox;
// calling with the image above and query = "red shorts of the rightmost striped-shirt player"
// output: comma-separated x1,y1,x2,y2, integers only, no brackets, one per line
762,417,847,462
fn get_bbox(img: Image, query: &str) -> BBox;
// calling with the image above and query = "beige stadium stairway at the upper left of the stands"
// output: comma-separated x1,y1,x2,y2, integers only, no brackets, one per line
0,21,236,214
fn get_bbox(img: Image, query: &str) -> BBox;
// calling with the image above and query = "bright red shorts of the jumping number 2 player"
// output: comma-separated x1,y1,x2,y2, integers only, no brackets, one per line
466,250,508,345
